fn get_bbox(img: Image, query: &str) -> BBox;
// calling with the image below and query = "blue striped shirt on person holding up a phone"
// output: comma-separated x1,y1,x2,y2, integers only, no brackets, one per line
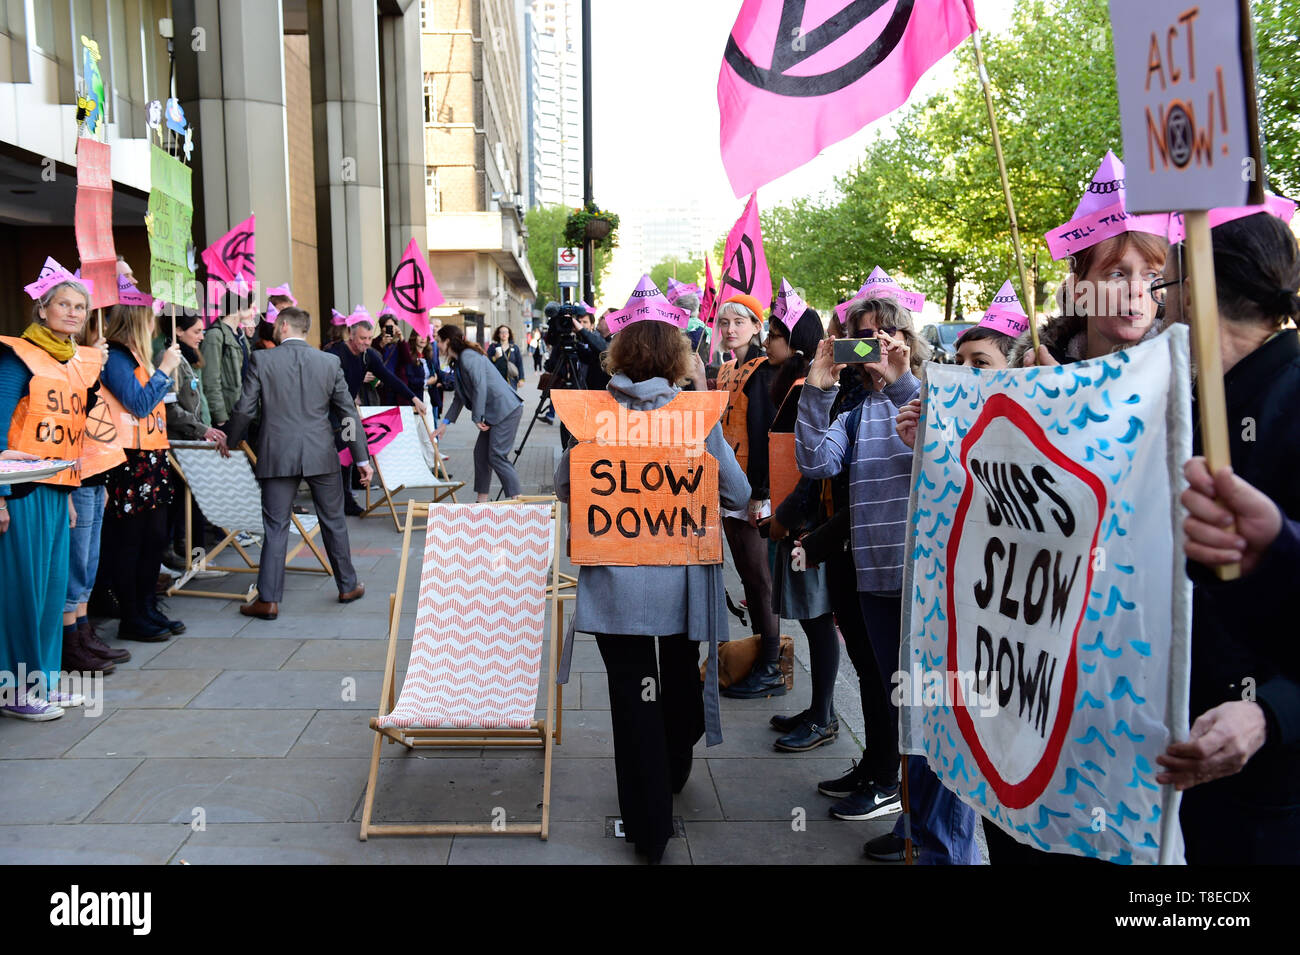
794,372,920,594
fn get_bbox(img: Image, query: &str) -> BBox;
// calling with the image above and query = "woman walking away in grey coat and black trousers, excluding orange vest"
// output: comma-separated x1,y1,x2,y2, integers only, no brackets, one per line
553,321,750,863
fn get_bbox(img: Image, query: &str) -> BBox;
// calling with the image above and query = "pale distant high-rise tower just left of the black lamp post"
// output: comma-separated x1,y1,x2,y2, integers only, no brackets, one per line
527,0,582,207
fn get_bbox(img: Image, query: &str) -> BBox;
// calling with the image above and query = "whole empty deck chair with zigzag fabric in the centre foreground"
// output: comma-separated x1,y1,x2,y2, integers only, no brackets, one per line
360,498,564,842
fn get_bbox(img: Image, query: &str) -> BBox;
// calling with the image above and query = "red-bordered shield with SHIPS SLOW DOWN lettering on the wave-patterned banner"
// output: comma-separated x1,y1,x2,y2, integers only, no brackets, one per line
945,395,1106,809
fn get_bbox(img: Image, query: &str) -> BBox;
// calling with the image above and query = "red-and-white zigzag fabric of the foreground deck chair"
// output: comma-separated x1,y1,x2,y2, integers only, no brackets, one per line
377,504,554,729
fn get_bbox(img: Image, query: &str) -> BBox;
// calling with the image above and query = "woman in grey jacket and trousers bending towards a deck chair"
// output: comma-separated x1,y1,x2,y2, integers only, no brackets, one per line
433,325,524,503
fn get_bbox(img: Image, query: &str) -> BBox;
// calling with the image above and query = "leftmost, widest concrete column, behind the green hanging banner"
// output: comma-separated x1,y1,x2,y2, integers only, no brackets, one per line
172,0,292,304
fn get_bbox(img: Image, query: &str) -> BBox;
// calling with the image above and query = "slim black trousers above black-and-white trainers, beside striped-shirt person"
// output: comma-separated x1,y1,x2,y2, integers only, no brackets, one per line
826,554,898,787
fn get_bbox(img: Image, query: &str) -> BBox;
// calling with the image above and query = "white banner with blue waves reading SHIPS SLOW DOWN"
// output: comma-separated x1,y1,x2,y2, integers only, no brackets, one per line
893,326,1191,863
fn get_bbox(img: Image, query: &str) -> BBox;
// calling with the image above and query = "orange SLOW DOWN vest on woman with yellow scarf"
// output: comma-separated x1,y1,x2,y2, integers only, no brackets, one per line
0,337,98,487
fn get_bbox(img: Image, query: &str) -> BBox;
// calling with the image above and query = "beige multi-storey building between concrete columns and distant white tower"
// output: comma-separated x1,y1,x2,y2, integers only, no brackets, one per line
420,0,537,342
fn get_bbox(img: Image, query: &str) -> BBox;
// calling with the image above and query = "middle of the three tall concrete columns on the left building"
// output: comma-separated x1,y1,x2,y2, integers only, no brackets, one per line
307,0,384,313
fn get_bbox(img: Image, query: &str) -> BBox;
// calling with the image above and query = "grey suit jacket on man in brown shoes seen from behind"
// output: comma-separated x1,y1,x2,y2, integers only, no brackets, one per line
225,339,371,478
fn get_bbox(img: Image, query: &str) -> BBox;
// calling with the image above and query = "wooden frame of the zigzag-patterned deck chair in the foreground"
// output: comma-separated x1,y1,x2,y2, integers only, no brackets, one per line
360,496,573,842
